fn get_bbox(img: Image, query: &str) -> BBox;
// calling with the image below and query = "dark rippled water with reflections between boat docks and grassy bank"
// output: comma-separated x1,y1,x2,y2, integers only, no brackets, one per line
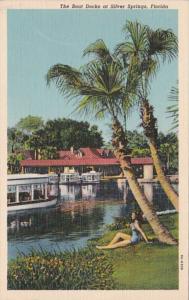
8,180,177,259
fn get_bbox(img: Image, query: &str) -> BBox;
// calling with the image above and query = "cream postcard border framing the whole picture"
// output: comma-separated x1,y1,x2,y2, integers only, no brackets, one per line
0,0,189,300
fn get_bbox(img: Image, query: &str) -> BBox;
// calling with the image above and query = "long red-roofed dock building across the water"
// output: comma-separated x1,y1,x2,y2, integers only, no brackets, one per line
21,147,153,179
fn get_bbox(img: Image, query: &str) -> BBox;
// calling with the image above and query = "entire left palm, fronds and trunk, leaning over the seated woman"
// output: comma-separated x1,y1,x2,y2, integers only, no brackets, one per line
47,40,176,244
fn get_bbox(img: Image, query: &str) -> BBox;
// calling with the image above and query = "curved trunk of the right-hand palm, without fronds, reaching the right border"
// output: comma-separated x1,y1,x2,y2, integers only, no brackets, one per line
141,100,178,211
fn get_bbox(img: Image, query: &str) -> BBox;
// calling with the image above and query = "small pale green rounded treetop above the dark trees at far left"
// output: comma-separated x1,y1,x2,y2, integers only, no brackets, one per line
15,115,44,135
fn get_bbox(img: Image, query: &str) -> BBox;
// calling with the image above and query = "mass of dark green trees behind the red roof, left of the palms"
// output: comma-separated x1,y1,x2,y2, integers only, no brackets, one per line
8,116,103,159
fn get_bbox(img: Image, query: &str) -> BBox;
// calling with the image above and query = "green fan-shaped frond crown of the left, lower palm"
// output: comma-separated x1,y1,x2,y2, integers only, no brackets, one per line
46,40,136,125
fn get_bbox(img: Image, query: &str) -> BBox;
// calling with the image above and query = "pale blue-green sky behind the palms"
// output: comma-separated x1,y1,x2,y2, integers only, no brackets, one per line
8,9,178,141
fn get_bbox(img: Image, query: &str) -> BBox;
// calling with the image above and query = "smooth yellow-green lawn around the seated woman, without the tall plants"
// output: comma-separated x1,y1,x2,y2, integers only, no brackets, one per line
89,214,178,290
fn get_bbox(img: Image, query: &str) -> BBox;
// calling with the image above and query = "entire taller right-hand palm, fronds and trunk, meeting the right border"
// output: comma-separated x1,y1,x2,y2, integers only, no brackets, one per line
116,22,178,210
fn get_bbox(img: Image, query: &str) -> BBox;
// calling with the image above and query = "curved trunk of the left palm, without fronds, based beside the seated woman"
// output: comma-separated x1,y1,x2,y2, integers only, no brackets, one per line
112,120,177,245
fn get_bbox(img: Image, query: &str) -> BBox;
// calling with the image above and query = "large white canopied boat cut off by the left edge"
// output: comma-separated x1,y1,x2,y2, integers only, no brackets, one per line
7,174,57,212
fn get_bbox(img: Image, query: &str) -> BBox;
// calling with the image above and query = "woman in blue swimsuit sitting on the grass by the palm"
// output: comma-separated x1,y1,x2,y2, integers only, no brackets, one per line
96,212,149,249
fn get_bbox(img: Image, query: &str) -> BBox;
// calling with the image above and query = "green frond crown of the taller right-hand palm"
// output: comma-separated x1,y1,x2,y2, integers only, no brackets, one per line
116,21,178,101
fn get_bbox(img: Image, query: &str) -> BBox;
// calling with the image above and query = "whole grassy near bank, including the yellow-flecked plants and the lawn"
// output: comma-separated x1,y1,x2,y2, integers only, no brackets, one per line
8,214,178,290
